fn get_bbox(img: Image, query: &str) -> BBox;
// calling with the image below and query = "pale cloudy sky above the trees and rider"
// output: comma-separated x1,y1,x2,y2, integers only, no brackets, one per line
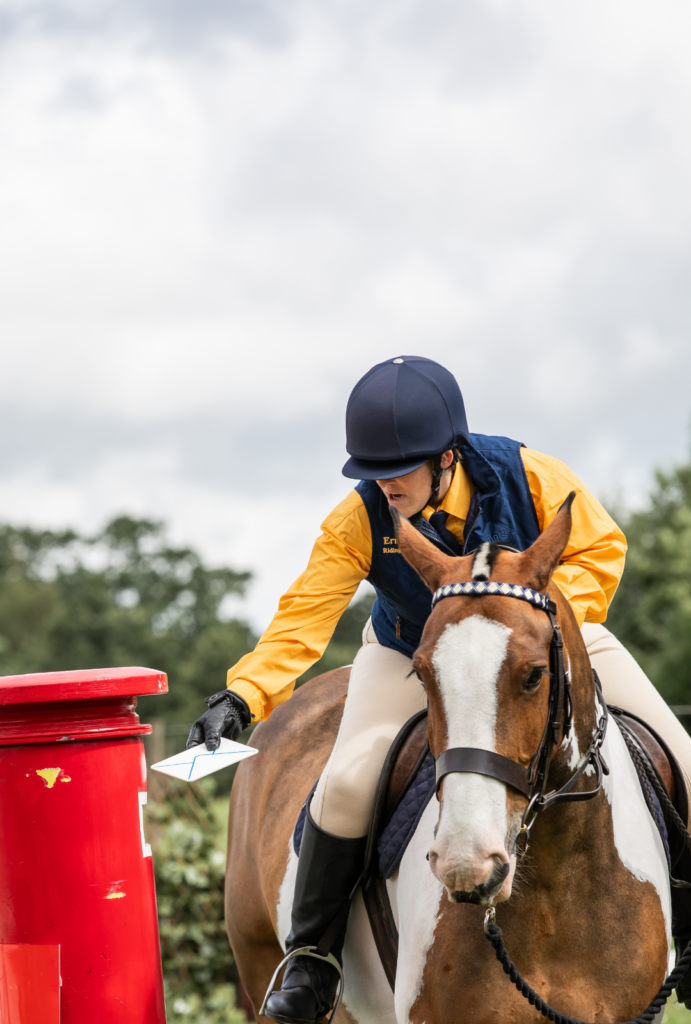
0,0,691,626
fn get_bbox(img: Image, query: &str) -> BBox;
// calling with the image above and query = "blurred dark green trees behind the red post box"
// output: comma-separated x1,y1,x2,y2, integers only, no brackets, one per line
0,516,255,723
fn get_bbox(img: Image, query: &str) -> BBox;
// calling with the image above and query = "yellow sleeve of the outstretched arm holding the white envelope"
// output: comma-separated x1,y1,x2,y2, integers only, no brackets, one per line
227,490,372,722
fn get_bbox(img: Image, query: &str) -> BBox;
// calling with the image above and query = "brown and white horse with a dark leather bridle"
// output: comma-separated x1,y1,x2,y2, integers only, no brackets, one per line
225,502,672,1024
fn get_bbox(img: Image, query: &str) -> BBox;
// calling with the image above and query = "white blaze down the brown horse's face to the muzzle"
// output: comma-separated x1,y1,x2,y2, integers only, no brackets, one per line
430,615,512,895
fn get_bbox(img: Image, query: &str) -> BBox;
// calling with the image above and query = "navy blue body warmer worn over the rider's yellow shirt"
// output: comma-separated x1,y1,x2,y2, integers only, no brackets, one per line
355,434,539,657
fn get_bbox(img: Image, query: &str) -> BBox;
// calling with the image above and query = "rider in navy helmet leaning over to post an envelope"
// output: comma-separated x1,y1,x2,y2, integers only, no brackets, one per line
187,356,691,1024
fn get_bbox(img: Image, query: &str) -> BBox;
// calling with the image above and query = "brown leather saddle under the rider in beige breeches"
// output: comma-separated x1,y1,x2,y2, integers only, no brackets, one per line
362,706,688,990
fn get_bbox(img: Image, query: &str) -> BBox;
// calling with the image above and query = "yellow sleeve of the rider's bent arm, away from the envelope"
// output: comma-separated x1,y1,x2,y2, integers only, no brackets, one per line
521,449,627,626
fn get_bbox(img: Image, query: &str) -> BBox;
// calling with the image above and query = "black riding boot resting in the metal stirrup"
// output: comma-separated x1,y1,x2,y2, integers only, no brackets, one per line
264,808,366,1024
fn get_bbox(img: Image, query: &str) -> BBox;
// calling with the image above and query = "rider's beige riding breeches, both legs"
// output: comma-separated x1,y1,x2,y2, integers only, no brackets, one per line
311,623,691,839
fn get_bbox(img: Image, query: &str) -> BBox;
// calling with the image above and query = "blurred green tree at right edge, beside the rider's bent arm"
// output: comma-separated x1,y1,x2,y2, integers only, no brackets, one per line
607,463,691,705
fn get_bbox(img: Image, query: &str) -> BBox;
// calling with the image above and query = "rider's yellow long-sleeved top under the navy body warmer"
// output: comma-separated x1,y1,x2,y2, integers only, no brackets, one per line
227,447,627,721
